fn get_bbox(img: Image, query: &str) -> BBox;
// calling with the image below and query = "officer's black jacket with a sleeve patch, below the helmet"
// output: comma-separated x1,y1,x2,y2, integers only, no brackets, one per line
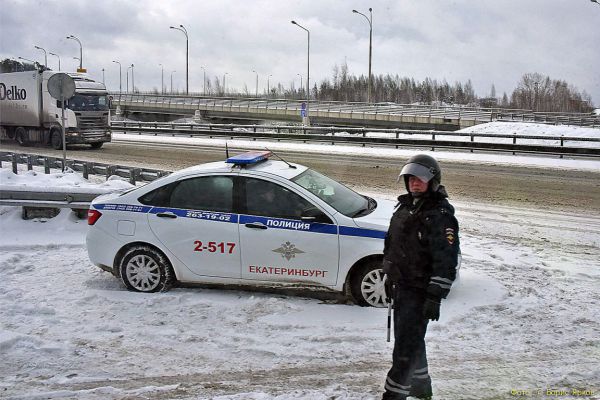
383,185,460,298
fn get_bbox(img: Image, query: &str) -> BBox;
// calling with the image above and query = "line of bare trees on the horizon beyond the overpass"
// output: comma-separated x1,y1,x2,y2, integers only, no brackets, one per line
0,59,594,113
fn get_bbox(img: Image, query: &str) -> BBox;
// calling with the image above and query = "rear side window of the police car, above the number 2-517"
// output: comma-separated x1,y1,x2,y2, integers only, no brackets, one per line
169,176,233,212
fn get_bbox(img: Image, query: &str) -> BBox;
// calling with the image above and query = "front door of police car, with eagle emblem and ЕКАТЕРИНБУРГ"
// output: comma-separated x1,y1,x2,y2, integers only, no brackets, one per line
239,178,339,285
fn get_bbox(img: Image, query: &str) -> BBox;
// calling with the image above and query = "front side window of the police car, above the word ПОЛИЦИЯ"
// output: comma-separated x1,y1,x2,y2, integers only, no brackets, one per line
246,178,328,222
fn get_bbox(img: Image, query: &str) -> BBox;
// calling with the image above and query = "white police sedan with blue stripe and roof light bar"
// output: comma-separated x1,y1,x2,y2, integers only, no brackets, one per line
86,152,394,306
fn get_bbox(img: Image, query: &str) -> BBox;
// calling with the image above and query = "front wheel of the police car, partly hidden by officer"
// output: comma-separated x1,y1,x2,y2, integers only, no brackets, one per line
350,260,387,307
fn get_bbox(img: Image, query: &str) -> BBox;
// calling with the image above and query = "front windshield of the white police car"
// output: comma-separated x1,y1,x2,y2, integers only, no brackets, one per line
291,169,374,217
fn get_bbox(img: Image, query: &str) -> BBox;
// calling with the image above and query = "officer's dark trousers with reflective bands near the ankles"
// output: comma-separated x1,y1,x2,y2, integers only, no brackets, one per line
383,286,431,400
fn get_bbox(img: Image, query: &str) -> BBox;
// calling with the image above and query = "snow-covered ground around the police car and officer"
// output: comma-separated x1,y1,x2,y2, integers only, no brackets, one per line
0,157,600,400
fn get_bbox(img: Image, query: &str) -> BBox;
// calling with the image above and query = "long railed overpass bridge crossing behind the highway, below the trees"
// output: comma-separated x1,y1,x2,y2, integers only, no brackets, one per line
111,93,600,131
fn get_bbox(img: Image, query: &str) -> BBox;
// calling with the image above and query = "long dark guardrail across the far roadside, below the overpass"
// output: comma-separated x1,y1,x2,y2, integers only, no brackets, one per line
112,121,600,157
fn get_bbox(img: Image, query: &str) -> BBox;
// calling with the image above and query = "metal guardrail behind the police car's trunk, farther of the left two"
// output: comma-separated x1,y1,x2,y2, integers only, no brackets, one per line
0,151,171,185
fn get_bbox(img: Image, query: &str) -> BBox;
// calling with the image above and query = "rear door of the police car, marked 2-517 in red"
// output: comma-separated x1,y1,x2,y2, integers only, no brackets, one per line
148,175,240,279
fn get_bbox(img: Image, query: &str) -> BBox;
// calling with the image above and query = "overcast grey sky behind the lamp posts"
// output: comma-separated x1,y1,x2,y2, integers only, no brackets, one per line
0,0,600,105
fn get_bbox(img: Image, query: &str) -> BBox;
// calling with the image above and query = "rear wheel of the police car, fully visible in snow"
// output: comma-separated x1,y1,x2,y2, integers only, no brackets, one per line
119,246,175,293
